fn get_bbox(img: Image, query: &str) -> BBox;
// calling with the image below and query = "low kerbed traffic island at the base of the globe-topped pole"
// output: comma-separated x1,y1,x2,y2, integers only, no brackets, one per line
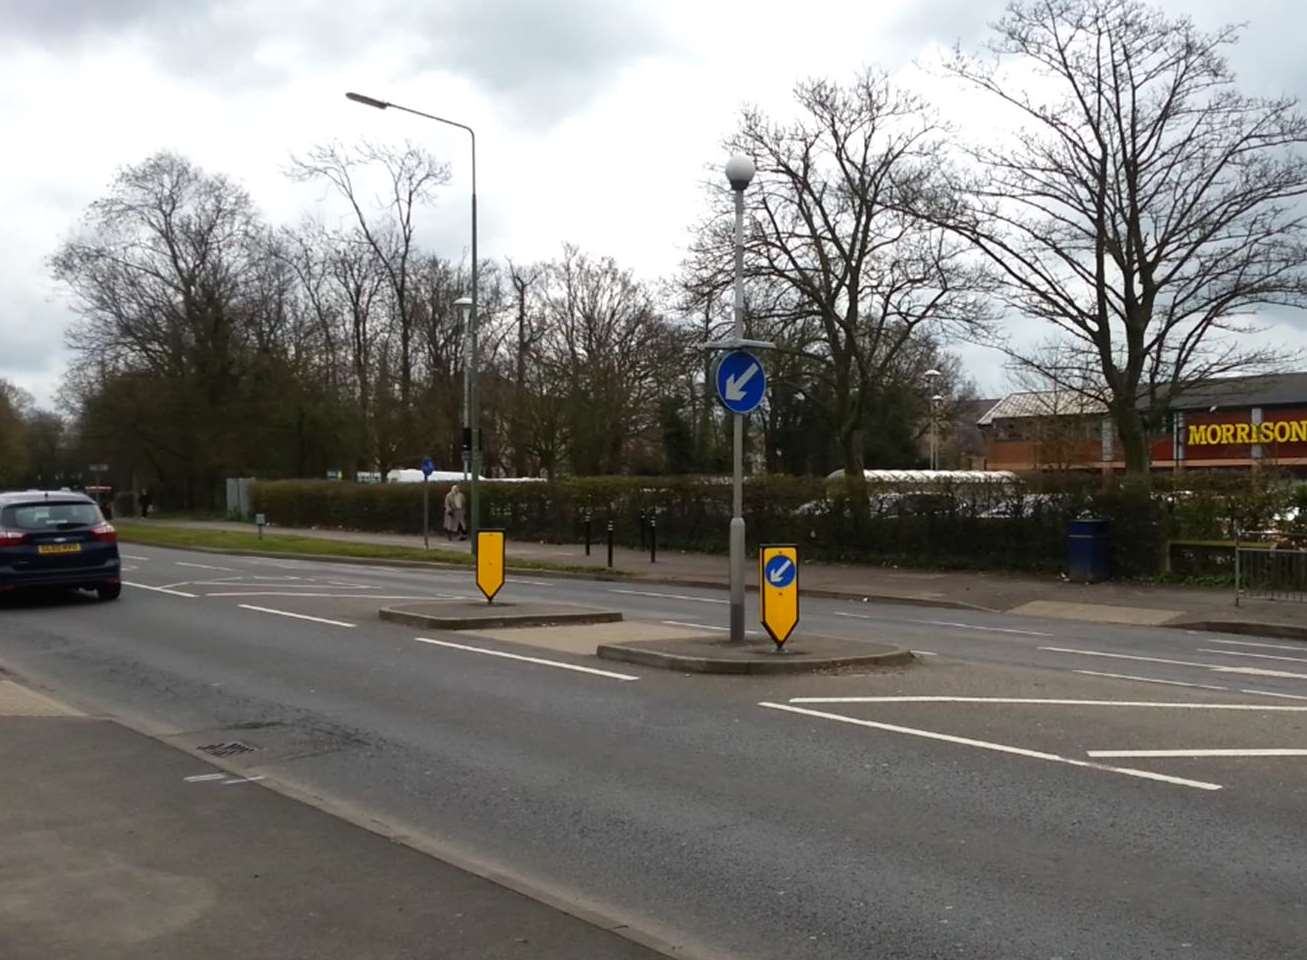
597,633,915,674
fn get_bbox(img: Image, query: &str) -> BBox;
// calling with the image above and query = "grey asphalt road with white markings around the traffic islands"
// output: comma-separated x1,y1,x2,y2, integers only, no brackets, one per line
0,546,1307,960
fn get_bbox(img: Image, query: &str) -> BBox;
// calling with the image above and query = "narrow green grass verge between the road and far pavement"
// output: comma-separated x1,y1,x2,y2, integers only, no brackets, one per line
114,520,626,579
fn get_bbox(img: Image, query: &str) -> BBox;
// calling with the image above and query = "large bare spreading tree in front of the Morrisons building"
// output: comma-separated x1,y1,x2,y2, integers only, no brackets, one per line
941,0,1307,473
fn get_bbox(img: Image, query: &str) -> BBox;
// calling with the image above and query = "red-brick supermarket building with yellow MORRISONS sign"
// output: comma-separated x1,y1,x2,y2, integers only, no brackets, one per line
972,374,1307,474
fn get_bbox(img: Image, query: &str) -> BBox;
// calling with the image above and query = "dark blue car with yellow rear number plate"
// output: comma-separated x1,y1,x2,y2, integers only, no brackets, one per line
0,490,123,600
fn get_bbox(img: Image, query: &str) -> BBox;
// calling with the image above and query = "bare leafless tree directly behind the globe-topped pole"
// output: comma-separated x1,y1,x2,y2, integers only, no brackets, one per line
706,72,985,483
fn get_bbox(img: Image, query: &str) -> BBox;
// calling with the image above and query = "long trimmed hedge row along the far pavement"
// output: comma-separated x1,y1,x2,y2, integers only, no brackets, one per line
254,472,1307,577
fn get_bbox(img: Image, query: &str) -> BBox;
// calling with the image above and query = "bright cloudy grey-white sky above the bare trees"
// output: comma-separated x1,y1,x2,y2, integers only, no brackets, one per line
0,0,1307,402
